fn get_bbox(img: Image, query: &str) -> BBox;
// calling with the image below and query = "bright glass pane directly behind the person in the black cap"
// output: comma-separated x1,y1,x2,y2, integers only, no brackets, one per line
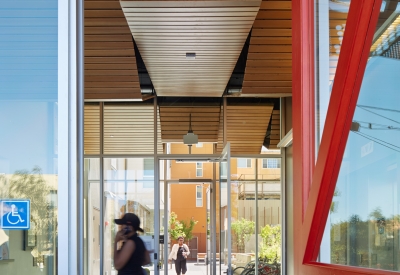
103,158,158,274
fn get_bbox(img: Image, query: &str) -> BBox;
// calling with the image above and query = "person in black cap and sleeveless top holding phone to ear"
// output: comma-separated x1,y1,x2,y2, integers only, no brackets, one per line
114,213,150,275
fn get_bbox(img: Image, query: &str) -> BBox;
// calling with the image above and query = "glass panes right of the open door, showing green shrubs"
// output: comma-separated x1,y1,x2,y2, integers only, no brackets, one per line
231,158,282,274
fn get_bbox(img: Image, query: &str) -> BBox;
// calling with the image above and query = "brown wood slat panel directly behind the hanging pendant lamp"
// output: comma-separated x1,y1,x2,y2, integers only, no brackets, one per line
159,106,221,142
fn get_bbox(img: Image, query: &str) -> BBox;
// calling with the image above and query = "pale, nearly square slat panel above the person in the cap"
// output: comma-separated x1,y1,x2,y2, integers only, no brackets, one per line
104,104,163,154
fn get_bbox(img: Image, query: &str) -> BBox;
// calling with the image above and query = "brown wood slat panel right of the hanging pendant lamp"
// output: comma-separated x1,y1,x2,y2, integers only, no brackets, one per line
217,104,274,154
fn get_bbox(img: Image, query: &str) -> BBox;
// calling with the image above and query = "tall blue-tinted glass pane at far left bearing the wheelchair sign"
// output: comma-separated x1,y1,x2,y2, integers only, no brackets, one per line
0,0,58,275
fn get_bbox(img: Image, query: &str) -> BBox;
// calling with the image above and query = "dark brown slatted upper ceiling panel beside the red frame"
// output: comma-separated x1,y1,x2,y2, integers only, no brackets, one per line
242,0,292,97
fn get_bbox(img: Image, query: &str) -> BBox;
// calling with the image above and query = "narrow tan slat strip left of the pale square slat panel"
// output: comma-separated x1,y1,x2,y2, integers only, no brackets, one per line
84,104,100,154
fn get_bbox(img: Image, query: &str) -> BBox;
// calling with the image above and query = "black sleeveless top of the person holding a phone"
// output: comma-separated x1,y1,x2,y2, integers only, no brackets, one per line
118,234,146,275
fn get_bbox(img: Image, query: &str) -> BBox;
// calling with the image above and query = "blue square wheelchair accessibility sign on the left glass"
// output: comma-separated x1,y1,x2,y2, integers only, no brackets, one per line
0,199,31,230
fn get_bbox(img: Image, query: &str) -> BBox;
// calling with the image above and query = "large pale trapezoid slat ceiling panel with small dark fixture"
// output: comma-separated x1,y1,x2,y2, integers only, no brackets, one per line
121,0,261,97
